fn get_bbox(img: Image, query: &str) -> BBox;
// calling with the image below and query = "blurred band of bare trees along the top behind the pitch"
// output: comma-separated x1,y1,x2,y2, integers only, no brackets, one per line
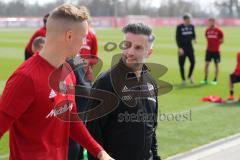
0,0,220,17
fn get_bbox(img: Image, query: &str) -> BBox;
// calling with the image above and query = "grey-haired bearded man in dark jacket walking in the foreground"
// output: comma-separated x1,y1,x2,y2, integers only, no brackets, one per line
87,23,160,160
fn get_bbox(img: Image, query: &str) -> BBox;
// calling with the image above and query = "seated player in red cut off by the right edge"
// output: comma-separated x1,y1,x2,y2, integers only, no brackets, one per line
228,52,240,102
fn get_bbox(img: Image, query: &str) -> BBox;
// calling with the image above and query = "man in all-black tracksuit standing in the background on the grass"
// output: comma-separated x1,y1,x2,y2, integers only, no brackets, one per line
176,14,196,84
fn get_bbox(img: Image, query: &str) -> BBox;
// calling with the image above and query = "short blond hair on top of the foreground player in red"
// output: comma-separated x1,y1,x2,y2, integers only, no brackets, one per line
49,3,89,22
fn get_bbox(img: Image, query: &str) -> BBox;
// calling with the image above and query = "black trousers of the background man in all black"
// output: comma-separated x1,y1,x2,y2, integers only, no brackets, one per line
178,48,195,80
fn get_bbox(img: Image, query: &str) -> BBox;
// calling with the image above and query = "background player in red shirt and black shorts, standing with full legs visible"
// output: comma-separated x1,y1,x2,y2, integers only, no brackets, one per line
201,18,224,85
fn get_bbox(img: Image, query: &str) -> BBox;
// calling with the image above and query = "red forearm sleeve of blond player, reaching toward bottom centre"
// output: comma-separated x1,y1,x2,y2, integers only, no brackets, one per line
70,121,103,157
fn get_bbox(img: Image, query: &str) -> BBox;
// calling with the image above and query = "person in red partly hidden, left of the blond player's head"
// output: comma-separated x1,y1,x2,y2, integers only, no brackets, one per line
25,14,49,60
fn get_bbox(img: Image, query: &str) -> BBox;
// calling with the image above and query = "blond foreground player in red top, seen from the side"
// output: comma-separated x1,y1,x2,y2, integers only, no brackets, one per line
0,4,112,160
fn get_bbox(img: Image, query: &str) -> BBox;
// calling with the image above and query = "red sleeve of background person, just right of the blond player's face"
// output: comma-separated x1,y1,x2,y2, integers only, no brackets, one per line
88,33,98,65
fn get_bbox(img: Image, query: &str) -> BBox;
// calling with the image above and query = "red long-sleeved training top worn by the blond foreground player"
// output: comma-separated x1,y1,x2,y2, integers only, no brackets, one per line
0,54,102,160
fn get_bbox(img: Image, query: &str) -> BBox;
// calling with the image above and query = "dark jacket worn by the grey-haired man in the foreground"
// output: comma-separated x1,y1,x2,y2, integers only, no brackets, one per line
87,60,160,160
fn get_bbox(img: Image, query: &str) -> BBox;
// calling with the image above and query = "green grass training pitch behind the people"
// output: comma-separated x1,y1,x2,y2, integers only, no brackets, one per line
0,27,240,159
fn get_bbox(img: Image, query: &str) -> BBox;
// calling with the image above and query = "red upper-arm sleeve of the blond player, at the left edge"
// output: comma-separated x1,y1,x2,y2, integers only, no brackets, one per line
0,73,35,119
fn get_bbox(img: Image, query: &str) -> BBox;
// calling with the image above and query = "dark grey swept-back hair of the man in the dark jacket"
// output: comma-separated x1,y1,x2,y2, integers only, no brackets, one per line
122,23,155,43
